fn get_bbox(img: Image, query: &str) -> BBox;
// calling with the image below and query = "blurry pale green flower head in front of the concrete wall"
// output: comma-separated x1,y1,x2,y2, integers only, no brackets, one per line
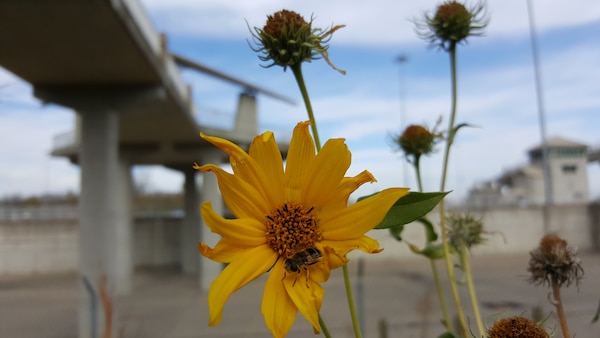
446,214,485,248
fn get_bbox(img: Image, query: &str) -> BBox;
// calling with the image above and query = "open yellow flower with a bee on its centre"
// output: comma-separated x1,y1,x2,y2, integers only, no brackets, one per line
194,122,408,337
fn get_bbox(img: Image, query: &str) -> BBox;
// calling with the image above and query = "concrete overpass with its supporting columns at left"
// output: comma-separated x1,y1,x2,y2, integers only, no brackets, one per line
0,0,290,337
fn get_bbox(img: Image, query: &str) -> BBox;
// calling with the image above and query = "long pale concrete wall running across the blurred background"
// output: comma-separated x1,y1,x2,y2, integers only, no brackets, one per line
0,203,600,274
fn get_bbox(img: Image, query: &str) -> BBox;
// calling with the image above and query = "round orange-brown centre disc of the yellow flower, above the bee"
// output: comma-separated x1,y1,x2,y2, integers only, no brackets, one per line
266,202,323,259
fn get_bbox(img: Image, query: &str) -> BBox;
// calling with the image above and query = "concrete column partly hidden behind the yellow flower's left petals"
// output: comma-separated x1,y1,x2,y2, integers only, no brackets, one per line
199,149,223,291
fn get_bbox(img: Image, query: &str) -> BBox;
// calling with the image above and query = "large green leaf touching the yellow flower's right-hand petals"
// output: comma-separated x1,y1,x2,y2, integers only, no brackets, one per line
358,192,448,229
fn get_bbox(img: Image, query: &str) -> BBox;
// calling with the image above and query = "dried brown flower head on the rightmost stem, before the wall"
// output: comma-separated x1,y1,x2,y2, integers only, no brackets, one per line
527,234,583,287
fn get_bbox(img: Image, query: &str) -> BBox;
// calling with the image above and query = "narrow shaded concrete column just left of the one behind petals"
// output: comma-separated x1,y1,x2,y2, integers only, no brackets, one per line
181,167,201,274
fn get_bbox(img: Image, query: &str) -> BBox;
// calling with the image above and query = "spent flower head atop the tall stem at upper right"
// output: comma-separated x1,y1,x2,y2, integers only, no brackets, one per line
415,1,489,50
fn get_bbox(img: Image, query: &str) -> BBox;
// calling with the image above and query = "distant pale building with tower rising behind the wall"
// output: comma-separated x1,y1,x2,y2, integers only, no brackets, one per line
467,137,589,208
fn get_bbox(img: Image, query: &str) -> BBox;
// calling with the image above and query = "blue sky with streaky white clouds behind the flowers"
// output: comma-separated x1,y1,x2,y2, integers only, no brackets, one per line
0,0,600,199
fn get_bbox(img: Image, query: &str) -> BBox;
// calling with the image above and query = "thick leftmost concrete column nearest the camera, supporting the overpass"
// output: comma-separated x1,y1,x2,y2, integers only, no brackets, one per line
79,109,122,338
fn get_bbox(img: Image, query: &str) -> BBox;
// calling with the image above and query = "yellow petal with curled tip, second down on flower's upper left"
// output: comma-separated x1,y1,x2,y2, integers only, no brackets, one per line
198,164,272,220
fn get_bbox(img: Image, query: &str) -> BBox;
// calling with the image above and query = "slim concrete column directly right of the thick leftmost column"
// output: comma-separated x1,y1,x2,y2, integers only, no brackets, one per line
113,155,133,296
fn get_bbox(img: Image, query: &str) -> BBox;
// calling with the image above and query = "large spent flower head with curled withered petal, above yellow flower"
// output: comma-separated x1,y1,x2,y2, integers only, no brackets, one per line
250,9,346,74
